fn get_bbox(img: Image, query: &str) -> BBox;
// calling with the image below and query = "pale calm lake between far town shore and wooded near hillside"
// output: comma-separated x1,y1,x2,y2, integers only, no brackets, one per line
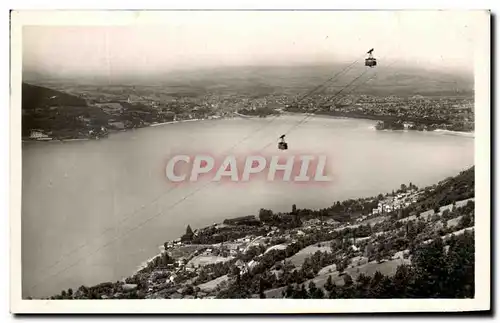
22,116,474,297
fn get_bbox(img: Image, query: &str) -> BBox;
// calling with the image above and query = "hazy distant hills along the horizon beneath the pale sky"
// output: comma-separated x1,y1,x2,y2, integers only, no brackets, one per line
25,63,474,96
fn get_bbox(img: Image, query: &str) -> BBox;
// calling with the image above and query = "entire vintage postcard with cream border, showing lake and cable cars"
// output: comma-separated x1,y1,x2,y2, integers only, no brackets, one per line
10,10,491,313
